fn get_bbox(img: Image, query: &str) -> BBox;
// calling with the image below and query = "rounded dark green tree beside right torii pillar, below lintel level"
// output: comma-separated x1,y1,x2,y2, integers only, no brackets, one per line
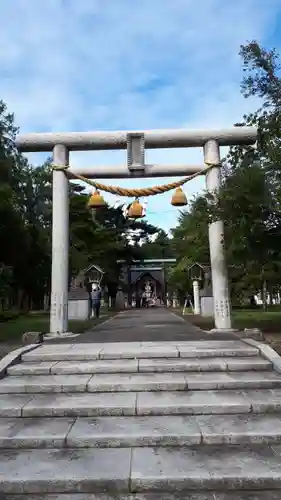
213,163,281,298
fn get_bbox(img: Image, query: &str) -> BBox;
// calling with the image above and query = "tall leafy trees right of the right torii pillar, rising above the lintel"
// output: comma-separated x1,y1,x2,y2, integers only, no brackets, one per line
221,41,281,304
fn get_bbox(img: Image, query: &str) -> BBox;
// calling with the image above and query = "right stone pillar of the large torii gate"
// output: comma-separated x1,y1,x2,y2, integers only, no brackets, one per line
204,140,232,331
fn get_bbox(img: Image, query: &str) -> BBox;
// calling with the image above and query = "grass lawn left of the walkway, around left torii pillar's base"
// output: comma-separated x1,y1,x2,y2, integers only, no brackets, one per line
0,310,115,343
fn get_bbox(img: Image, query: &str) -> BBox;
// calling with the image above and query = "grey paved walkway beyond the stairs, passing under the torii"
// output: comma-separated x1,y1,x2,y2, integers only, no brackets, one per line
48,308,236,343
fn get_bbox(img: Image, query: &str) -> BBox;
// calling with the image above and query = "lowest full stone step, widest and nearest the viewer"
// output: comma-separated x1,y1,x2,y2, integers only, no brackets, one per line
0,445,281,498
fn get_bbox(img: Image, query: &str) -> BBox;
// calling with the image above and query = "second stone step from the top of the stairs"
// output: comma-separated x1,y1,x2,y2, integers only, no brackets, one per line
8,356,272,375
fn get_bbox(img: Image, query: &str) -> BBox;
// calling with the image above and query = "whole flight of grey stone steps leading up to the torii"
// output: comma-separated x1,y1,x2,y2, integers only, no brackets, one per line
0,311,281,500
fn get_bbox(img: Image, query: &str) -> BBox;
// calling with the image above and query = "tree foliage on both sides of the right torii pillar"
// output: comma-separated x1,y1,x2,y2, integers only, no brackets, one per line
171,41,281,299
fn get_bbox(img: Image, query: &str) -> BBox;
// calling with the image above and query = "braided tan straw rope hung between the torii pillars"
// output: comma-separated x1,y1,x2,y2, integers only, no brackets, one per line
52,165,213,198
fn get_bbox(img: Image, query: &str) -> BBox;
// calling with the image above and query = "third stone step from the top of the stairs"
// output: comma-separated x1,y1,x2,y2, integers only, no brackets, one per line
0,371,281,394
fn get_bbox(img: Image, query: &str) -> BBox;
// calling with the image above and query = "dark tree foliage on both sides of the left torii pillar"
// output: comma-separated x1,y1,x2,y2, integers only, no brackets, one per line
0,97,165,308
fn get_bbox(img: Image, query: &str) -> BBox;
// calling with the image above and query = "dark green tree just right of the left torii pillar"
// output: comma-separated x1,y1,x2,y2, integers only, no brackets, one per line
70,192,160,296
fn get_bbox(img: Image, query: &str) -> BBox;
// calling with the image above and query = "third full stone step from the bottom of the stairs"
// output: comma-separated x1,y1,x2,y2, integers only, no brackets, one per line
0,389,281,418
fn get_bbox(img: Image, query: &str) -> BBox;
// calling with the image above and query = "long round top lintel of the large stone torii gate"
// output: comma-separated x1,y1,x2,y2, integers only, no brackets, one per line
16,126,257,152
